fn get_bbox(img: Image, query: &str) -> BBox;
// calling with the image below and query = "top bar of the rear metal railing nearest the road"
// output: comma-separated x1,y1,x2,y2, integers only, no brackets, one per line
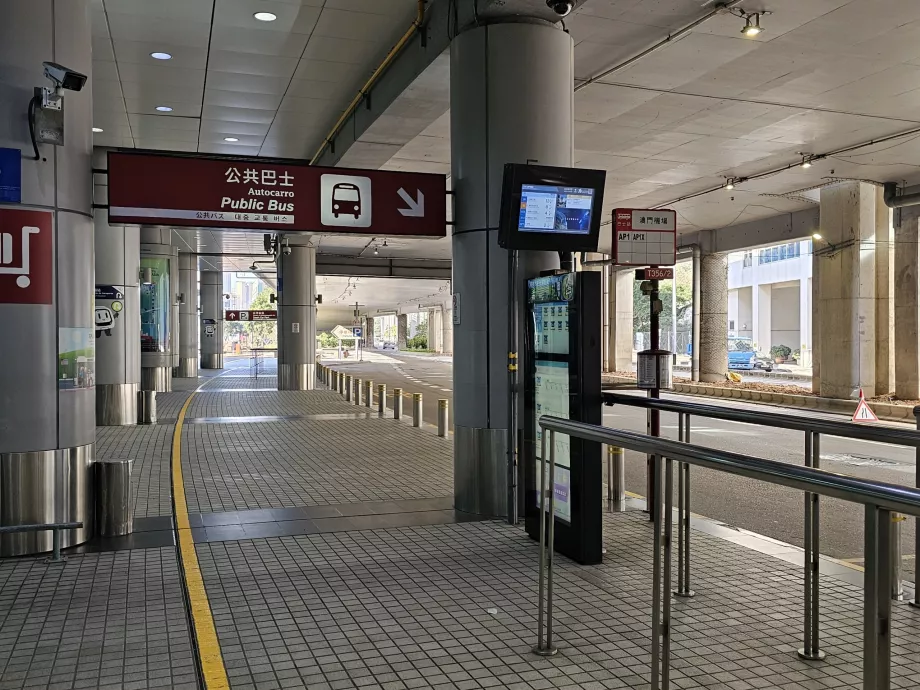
601,391,920,448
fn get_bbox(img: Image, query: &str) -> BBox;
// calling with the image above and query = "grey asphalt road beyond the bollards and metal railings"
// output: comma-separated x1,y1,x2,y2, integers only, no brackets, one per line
328,351,917,578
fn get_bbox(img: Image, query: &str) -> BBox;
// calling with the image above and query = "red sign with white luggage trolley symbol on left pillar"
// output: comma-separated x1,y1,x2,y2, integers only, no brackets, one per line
0,208,54,304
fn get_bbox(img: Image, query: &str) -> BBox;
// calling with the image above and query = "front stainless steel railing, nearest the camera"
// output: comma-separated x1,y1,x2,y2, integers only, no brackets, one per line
536,416,920,690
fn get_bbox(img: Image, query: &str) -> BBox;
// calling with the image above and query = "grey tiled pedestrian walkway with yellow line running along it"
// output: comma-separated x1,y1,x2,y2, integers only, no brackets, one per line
0,359,920,690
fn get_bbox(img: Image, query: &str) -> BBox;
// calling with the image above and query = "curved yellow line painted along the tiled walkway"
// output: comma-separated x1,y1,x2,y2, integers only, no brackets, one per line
172,376,230,690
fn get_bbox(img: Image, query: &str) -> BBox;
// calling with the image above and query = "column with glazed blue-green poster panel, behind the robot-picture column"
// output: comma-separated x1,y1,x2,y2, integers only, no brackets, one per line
140,227,179,392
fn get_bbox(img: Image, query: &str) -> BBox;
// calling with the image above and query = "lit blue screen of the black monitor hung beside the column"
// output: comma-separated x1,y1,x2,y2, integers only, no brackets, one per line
518,184,594,235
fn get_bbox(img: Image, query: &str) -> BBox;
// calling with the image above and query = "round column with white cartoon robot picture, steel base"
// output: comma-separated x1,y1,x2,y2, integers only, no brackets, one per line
94,200,141,426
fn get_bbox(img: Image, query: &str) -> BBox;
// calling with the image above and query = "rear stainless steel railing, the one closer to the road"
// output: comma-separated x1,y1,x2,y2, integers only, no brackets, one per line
603,391,920,660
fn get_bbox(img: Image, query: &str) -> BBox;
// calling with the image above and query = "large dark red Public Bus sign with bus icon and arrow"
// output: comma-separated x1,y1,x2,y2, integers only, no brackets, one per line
109,151,447,237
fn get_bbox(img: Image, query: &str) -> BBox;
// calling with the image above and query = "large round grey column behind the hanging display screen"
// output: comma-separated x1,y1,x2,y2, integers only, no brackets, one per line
450,18,574,516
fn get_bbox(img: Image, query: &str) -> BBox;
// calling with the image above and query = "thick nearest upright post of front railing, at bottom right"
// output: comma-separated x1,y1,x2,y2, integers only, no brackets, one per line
863,505,891,690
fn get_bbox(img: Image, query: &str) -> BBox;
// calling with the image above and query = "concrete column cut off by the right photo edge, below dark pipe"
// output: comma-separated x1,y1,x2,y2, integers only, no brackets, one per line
894,206,920,400
